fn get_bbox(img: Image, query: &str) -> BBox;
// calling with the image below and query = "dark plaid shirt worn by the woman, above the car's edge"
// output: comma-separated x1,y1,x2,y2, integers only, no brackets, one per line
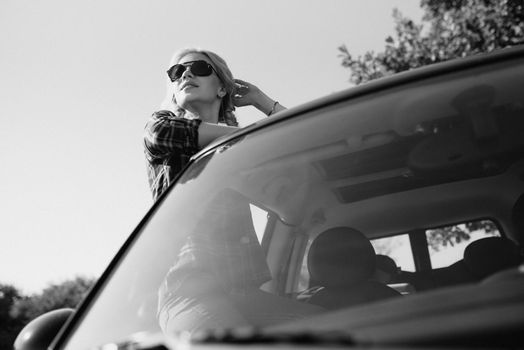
144,110,201,200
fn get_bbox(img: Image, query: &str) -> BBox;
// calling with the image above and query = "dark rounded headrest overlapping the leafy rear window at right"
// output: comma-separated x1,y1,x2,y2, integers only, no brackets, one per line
464,237,520,278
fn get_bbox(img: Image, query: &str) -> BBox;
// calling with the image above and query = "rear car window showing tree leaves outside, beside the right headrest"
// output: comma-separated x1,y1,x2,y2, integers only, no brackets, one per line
426,220,500,269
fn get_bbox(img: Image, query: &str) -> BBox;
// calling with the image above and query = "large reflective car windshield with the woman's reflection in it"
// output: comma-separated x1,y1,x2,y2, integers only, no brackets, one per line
59,50,524,349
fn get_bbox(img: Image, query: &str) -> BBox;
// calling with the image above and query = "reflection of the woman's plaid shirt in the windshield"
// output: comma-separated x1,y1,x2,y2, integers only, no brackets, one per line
164,189,271,290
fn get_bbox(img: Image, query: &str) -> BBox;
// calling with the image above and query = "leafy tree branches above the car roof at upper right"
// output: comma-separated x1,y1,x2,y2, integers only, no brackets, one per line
339,0,524,84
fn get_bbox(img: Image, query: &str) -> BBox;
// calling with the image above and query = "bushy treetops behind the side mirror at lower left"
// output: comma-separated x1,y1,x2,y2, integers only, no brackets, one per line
11,277,95,323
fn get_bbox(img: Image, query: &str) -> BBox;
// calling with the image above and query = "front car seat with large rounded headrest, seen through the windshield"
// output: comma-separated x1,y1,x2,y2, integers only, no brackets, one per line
307,227,400,309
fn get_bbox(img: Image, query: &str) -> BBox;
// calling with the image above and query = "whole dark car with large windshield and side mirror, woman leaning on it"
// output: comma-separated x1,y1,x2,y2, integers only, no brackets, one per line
15,46,524,350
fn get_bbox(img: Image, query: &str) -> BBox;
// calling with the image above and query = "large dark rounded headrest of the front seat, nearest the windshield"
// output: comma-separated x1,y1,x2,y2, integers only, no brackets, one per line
307,227,375,287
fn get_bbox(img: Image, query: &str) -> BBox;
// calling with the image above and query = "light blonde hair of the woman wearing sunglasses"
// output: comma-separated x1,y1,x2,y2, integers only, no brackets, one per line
160,48,238,126
